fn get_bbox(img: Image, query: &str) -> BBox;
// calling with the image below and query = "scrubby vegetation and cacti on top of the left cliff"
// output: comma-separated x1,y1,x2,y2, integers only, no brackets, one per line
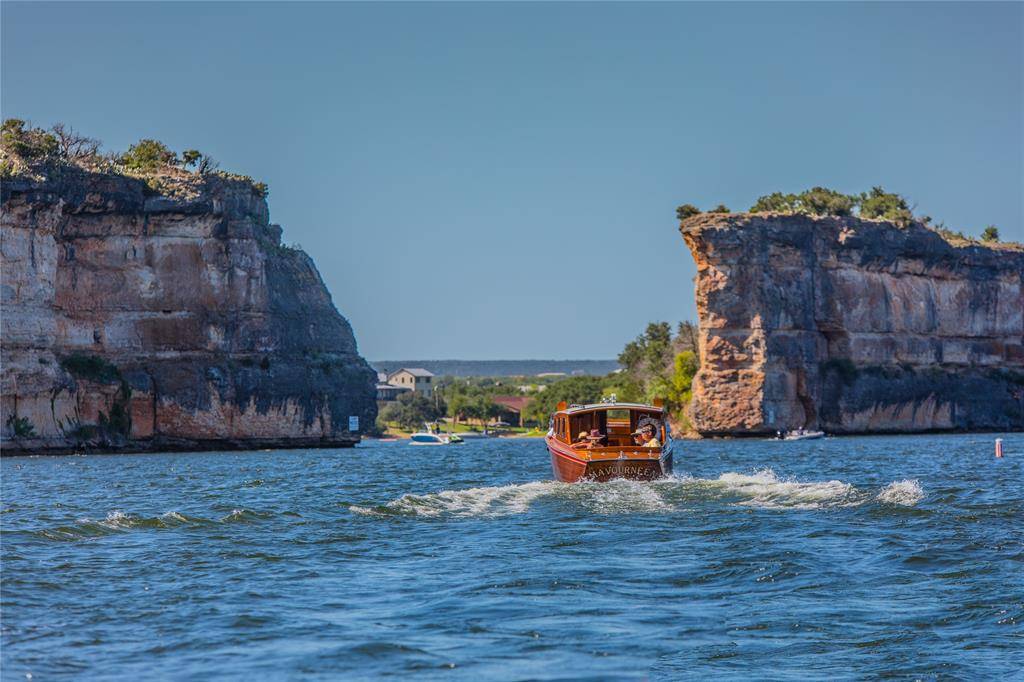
0,119,268,197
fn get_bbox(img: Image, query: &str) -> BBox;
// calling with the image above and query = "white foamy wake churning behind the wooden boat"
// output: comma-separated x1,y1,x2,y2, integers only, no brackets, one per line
349,469,925,517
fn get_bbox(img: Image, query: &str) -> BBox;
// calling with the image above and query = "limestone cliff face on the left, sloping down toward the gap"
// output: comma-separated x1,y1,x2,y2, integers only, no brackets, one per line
0,169,376,455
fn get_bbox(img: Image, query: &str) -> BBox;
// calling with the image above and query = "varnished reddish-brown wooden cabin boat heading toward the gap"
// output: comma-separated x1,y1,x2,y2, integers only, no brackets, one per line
545,398,673,482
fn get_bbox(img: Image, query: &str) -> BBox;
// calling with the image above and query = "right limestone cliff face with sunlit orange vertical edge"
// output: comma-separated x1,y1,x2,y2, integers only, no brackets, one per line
681,214,1024,435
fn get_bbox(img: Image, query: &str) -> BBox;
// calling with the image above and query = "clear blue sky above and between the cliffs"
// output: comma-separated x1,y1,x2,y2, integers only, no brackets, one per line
2,2,1024,359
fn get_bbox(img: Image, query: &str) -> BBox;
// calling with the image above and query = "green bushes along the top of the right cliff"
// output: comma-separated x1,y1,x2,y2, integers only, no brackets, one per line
676,187,1013,245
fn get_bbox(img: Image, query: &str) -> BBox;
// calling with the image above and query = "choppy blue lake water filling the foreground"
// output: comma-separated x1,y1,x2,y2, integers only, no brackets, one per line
0,434,1024,680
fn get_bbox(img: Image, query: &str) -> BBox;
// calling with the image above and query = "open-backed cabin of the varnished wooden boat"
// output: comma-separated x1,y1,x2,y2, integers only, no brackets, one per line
551,400,669,452
